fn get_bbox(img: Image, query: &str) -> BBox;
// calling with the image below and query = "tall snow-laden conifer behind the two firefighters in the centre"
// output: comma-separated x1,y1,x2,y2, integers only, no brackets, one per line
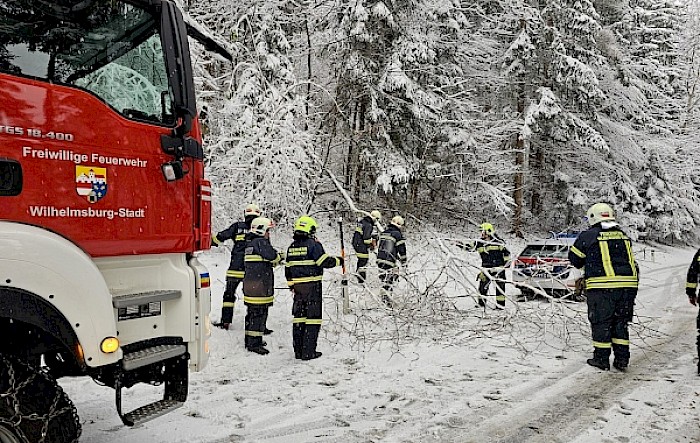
322,0,476,213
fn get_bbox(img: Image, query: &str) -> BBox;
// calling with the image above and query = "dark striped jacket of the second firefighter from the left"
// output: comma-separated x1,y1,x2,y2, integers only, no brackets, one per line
243,234,282,305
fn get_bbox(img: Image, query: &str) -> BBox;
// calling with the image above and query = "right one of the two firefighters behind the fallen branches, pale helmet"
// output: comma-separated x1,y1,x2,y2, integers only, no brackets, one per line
377,215,406,308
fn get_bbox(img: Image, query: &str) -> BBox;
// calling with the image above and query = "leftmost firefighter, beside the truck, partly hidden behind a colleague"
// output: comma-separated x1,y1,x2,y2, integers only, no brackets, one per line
211,203,260,329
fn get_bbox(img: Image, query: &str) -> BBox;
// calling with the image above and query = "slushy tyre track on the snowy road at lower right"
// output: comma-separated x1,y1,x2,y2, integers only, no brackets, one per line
441,304,695,443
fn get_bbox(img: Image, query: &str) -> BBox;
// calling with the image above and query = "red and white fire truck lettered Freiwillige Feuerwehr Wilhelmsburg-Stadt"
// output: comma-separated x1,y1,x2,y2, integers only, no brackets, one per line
0,0,224,443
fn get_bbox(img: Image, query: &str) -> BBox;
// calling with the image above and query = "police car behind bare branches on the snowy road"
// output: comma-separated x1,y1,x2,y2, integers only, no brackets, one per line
513,233,583,301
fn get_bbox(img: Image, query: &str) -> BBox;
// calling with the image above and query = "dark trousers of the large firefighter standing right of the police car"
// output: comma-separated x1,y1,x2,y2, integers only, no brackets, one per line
586,288,637,365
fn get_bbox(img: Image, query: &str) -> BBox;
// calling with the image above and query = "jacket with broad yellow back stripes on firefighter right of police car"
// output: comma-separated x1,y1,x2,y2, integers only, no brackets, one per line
569,222,639,289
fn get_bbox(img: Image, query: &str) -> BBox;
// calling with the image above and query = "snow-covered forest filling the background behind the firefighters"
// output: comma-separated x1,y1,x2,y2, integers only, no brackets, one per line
181,0,700,243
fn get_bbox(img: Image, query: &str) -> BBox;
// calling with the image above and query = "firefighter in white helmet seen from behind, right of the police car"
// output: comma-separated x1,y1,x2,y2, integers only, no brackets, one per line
569,203,639,371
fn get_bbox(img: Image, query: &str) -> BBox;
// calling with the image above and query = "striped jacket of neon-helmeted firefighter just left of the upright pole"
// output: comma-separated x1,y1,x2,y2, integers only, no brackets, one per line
284,236,340,287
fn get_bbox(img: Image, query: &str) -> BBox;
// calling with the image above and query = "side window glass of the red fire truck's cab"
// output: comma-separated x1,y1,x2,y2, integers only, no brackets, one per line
0,0,175,126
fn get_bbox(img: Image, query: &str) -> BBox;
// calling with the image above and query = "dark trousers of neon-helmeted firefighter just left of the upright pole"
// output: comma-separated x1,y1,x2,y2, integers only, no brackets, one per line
292,282,323,358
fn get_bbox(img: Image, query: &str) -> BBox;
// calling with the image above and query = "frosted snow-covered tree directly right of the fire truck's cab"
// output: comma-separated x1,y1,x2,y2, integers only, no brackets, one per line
187,2,318,225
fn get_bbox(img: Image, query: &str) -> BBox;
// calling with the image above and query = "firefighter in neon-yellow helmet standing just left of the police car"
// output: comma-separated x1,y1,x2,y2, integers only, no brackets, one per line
457,223,510,308
